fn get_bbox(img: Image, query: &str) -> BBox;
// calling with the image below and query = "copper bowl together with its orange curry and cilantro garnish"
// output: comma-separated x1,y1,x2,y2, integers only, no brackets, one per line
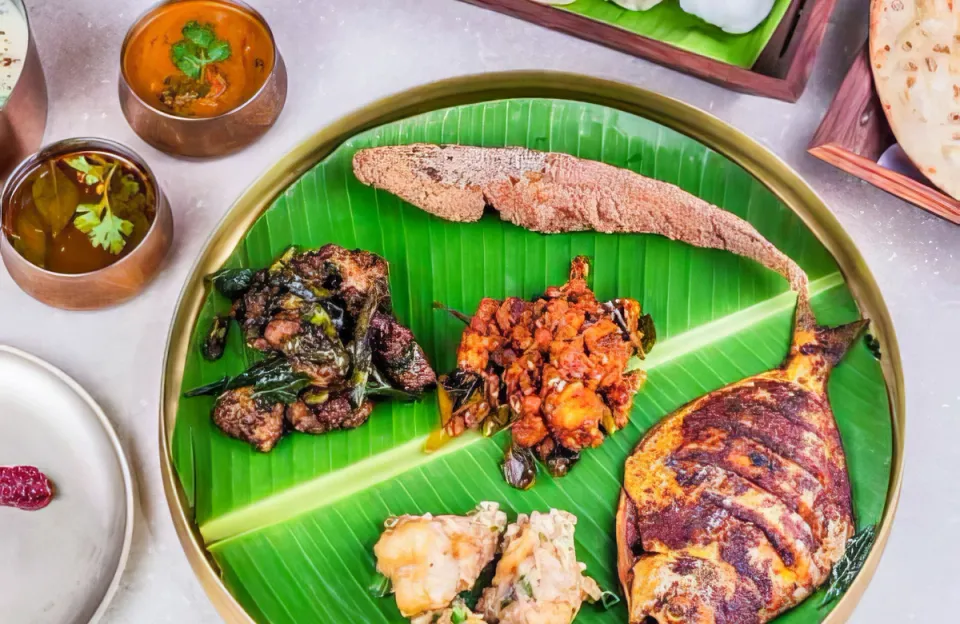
119,0,287,157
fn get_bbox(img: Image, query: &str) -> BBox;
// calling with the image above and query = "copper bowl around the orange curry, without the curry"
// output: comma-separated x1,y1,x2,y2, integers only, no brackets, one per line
120,0,287,158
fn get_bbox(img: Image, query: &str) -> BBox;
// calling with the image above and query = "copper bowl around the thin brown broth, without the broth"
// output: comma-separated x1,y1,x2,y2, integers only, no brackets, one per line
0,138,173,310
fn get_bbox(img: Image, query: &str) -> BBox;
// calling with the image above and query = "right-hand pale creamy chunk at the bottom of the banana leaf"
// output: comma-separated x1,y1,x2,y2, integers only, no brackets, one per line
477,509,602,624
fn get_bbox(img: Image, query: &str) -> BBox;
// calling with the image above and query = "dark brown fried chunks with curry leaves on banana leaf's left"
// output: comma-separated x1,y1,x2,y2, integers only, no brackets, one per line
187,245,436,453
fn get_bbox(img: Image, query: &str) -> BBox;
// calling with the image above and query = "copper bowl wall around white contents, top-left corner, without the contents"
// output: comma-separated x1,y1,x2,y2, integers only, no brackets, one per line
0,0,47,182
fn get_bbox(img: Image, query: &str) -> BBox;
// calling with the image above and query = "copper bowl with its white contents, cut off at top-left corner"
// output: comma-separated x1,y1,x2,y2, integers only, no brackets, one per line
0,0,47,183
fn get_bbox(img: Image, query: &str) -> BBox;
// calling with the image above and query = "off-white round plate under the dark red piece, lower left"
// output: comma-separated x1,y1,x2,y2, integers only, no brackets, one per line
0,345,133,624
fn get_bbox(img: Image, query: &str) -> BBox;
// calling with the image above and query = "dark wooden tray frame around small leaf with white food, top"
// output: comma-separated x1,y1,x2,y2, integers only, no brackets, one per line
464,0,836,102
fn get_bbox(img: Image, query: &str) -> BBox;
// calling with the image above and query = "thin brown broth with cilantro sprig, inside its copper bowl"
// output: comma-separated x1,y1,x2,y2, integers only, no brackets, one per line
3,151,156,274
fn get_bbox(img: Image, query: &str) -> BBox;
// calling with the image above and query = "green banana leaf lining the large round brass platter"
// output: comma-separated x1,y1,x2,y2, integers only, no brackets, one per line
172,99,892,623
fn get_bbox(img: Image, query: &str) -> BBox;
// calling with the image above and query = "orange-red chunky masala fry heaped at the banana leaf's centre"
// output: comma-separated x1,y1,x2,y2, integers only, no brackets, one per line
440,256,654,488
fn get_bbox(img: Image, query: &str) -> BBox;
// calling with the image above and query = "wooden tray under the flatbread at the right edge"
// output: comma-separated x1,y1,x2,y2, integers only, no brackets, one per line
808,46,960,224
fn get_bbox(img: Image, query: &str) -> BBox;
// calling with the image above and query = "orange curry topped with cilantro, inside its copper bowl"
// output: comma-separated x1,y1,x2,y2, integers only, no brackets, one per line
123,0,274,117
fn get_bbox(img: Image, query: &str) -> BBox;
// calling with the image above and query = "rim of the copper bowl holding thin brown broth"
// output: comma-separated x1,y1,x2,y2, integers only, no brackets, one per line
0,137,167,280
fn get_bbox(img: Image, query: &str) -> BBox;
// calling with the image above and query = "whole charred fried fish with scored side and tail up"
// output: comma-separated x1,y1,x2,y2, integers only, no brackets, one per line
617,321,866,624
